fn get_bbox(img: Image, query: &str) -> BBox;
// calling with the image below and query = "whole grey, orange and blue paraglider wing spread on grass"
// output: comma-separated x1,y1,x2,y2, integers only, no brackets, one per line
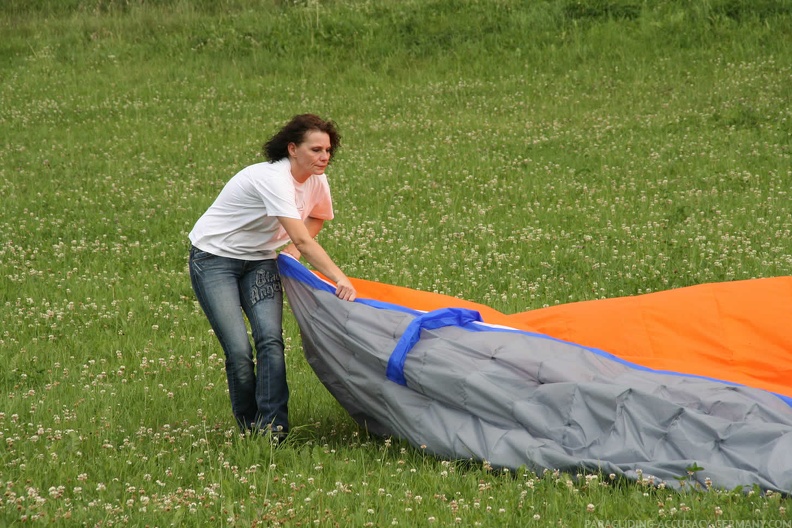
279,256,792,494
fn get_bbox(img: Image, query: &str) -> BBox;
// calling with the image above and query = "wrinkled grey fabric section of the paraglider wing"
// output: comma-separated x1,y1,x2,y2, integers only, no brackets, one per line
283,277,792,493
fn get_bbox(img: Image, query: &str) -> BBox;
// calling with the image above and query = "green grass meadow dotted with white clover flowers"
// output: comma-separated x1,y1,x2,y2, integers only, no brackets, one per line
0,0,792,527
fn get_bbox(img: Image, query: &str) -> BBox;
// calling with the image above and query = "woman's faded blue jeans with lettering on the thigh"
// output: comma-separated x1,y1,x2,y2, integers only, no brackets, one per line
190,247,289,436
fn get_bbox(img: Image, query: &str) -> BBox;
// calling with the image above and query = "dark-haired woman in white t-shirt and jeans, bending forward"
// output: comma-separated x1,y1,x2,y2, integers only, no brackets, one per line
189,114,355,440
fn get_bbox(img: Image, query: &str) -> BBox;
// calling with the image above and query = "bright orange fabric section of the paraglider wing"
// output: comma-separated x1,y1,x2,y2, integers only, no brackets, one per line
344,277,792,396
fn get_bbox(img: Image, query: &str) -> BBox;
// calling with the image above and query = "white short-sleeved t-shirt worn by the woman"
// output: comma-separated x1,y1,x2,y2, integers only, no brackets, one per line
189,159,333,260
